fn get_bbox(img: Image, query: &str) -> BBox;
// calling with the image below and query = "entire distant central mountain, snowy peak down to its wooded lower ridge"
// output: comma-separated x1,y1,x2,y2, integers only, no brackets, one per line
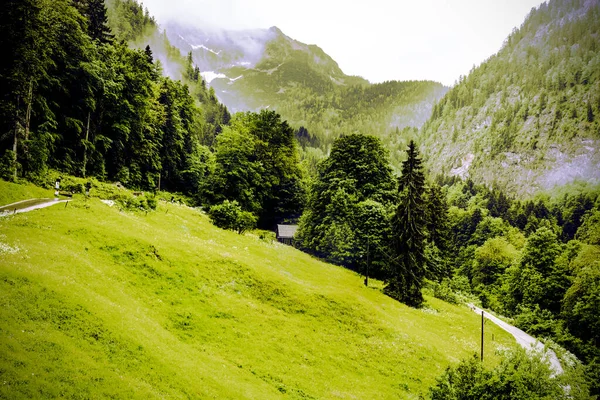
165,23,447,164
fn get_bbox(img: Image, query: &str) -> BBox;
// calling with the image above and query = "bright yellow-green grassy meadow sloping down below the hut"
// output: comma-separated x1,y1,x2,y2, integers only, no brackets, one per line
0,181,514,399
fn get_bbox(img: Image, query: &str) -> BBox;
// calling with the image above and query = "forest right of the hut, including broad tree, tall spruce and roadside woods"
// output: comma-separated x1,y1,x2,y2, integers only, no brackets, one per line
298,135,600,393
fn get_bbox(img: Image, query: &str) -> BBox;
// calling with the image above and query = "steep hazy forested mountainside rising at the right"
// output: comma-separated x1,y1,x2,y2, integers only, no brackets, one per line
422,0,600,194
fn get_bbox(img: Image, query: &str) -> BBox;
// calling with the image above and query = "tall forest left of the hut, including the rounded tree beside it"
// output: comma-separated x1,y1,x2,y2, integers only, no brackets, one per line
0,0,304,231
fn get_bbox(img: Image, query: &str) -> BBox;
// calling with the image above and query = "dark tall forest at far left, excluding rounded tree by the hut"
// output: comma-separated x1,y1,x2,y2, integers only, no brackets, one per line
0,0,228,197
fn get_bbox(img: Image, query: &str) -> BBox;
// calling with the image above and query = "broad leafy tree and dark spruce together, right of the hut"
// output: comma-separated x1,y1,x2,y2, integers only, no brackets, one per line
297,135,449,306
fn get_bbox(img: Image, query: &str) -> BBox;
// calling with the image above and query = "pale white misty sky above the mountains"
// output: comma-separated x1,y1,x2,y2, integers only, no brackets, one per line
143,0,541,85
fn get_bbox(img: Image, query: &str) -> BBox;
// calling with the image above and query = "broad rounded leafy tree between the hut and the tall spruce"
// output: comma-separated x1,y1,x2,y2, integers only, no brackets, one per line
297,135,396,277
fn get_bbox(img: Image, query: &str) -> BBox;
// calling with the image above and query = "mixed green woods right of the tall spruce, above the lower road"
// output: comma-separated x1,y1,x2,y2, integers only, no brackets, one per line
433,177,600,394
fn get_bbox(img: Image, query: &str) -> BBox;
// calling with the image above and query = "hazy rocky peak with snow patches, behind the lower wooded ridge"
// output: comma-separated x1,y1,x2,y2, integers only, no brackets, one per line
165,22,369,111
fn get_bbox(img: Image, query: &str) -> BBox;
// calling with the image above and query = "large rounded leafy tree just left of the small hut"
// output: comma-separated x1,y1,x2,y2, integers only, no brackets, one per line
206,110,304,228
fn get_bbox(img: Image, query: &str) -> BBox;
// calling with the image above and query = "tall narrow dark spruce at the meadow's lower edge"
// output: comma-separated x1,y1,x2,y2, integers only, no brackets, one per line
385,140,427,307
